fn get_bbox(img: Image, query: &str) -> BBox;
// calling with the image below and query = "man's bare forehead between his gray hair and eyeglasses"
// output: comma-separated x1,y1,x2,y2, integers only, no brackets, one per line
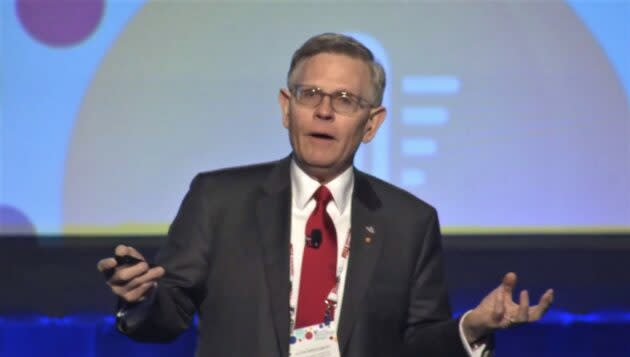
294,53,371,95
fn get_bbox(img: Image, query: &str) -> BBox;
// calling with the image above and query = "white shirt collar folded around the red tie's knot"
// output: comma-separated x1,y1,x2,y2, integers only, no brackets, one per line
291,159,354,214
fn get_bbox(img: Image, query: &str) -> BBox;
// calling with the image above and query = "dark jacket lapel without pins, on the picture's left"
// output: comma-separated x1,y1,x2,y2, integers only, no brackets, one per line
256,158,291,357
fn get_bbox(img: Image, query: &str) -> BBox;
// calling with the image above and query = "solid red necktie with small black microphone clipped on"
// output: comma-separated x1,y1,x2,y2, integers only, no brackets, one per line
295,186,337,328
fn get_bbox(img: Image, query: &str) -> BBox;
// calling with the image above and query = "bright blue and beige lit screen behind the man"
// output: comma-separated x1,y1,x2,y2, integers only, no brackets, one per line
0,0,630,235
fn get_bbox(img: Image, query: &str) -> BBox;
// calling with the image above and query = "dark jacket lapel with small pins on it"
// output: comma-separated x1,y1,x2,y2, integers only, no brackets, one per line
337,170,385,355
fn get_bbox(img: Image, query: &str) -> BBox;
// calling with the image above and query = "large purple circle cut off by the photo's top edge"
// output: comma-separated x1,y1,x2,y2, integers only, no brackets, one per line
16,0,105,47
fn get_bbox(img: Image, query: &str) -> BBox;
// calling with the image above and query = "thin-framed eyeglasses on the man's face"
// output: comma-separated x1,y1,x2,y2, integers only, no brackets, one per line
291,85,372,115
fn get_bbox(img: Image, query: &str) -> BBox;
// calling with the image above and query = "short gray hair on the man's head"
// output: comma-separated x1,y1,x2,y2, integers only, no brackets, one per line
287,32,385,106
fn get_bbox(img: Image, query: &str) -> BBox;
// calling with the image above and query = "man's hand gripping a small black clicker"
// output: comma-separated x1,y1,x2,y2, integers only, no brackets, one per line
96,245,165,303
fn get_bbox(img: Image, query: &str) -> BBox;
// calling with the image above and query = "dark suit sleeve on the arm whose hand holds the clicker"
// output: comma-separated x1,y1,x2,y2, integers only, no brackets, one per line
117,176,211,342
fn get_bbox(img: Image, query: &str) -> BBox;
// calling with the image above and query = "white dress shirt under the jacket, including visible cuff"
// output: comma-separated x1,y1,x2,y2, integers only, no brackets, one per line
290,161,485,357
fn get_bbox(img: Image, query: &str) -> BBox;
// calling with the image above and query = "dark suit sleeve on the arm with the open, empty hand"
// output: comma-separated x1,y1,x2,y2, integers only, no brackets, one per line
404,209,468,357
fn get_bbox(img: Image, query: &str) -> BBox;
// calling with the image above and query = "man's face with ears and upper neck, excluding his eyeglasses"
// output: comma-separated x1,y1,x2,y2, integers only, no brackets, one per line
279,53,385,183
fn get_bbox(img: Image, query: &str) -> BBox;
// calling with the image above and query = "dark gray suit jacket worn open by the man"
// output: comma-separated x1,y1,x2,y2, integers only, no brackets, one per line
119,157,466,357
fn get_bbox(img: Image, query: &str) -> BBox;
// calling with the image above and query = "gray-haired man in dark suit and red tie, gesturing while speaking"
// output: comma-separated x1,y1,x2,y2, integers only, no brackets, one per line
98,34,553,357
